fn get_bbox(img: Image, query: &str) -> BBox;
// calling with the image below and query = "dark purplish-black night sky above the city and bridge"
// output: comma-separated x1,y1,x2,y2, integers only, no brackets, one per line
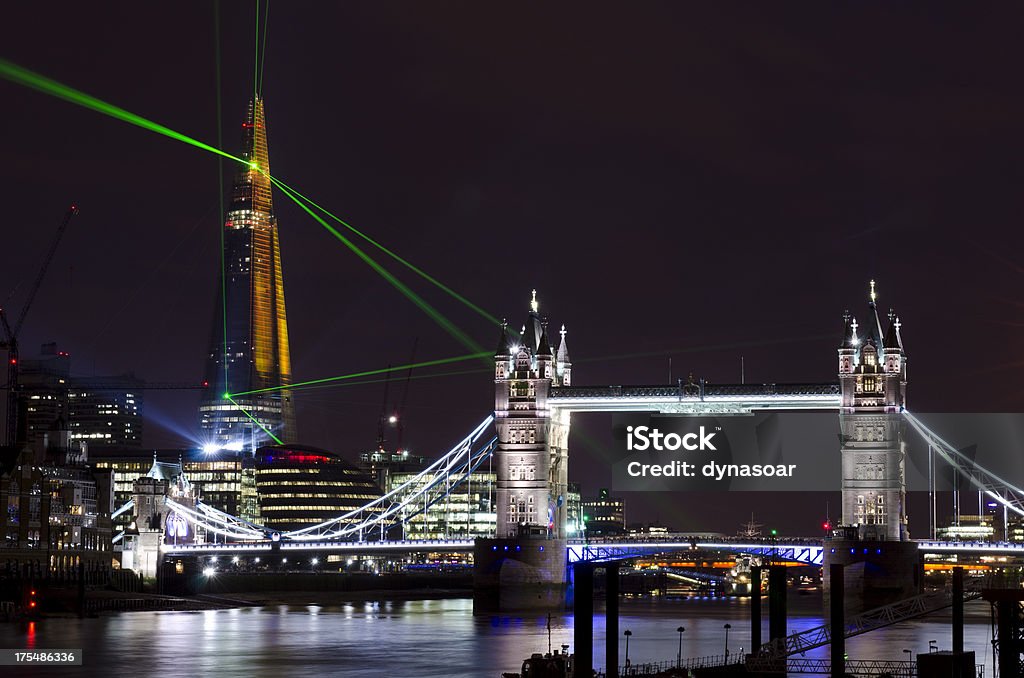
0,1,1024,534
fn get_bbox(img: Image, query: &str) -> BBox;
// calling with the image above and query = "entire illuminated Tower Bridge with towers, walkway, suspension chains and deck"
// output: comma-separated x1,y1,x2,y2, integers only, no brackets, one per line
116,283,1024,608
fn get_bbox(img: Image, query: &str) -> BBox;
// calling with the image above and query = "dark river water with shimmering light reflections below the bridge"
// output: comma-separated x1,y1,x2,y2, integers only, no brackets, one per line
0,597,992,678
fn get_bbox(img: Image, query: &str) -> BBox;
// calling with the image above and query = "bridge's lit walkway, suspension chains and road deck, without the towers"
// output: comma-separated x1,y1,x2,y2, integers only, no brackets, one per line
123,403,1024,565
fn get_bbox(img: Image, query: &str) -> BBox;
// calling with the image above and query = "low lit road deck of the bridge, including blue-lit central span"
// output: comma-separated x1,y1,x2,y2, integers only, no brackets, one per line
161,535,1024,565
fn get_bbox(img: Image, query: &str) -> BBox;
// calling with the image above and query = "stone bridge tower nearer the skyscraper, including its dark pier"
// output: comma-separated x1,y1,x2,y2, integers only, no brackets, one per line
474,290,572,609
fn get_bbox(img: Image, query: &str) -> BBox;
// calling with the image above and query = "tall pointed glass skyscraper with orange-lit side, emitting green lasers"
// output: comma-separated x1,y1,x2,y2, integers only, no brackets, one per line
200,97,295,450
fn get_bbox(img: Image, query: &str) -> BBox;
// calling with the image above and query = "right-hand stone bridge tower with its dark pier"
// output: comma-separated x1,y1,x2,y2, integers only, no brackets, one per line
823,281,921,609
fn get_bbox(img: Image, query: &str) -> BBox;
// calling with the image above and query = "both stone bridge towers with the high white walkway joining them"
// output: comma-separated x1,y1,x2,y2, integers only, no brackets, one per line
474,281,920,608
